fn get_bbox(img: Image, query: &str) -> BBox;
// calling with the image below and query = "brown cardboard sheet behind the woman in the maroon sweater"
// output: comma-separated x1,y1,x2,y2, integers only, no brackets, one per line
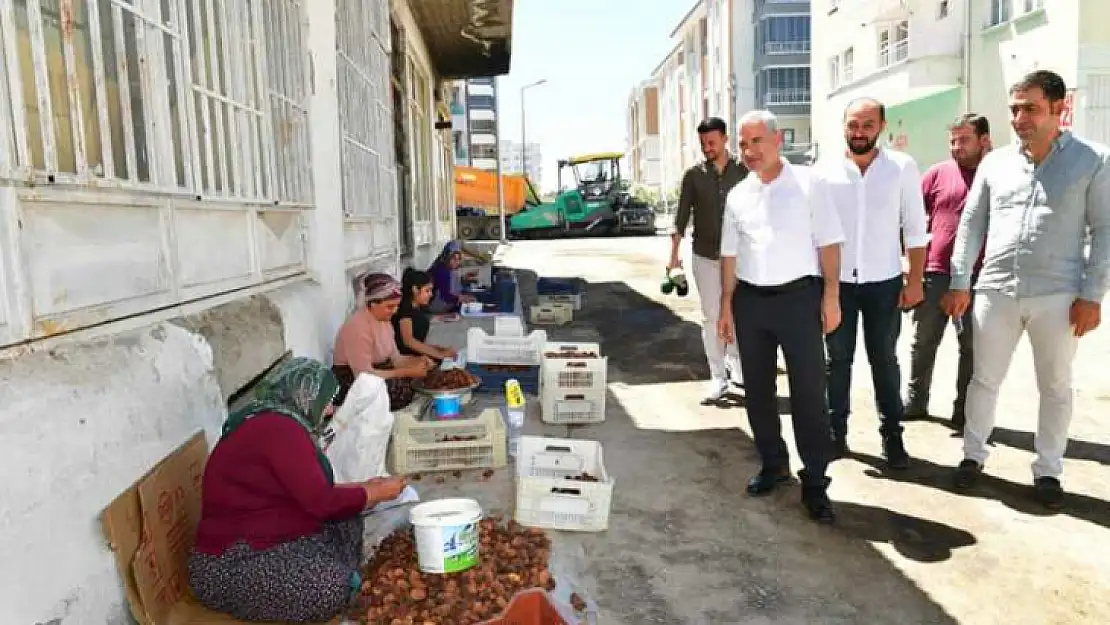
101,432,341,625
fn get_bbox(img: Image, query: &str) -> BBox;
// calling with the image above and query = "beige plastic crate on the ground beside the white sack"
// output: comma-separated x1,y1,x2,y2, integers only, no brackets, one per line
390,402,508,475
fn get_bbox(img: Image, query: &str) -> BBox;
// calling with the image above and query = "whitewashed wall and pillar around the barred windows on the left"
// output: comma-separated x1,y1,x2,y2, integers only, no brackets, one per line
0,0,451,625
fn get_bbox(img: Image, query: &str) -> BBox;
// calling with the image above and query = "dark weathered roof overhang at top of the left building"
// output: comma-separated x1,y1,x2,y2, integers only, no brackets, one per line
408,0,513,79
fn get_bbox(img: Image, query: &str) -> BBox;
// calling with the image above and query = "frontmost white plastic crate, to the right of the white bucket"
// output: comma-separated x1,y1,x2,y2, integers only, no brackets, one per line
514,436,614,532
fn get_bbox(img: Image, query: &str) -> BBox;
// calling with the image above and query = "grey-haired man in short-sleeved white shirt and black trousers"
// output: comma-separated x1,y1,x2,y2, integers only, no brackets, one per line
717,111,844,523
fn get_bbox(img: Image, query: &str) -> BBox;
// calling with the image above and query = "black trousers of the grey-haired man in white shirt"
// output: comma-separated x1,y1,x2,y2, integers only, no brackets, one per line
733,278,833,484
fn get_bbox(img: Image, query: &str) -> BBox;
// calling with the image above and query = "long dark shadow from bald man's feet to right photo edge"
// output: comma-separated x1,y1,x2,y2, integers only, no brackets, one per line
849,453,1110,527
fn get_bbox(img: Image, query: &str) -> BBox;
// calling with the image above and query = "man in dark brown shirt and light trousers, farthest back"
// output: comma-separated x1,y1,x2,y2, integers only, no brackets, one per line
667,118,748,402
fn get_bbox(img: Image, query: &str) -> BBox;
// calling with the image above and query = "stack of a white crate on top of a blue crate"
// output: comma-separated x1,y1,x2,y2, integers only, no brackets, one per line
466,327,547,394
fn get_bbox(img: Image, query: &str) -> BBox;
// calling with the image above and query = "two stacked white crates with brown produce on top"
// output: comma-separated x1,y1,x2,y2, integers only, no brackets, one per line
539,343,609,425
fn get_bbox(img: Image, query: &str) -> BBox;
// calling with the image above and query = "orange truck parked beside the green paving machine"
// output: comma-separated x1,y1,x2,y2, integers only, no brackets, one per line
455,167,541,240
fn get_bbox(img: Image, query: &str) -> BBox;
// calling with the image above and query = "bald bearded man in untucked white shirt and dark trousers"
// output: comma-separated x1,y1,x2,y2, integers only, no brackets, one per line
817,98,929,470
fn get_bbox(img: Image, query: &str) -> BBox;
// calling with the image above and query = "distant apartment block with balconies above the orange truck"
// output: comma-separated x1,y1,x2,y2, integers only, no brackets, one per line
451,78,497,171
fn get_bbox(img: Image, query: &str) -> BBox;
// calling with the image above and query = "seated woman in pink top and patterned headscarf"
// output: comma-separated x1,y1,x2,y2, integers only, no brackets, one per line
332,273,435,411
